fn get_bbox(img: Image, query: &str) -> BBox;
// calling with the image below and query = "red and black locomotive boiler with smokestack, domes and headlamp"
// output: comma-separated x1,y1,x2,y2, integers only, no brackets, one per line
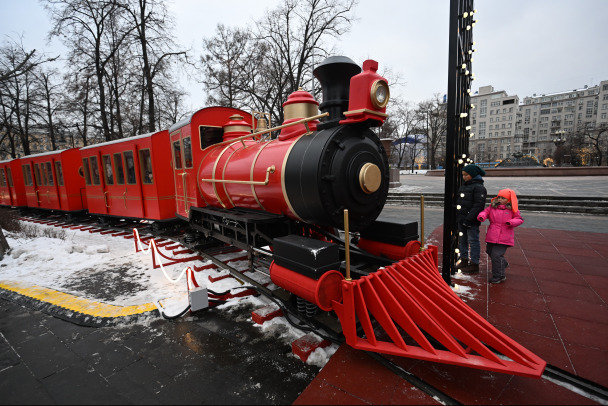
198,57,388,235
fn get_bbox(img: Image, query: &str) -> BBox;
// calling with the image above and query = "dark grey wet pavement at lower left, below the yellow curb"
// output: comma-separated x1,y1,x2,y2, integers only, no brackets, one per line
0,299,319,404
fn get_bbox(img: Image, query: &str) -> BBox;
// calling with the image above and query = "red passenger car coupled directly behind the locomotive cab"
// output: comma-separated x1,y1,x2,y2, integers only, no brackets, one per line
80,130,175,220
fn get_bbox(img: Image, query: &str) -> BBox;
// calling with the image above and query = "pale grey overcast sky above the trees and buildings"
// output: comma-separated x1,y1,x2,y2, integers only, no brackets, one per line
0,0,608,108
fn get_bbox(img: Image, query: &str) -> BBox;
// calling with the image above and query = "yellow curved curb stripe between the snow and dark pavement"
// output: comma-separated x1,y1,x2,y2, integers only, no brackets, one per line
0,281,156,317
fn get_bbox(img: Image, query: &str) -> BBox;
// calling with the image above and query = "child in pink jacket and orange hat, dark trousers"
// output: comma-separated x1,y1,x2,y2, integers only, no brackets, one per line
477,189,524,283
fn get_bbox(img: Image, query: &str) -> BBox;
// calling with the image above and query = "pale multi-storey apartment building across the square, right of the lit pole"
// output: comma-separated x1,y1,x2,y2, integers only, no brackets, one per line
469,80,608,162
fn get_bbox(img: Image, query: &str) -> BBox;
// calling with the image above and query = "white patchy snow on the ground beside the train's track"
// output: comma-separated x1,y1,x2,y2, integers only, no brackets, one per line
0,222,338,367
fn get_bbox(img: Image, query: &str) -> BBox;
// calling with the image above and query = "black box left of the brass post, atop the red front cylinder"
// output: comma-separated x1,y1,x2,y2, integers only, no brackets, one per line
272,235,340,280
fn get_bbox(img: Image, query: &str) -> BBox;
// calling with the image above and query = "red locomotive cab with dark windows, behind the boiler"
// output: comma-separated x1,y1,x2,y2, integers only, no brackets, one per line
169,107,253,219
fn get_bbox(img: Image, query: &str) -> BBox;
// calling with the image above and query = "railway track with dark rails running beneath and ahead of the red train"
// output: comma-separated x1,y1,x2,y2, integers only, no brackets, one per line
8,211,608,405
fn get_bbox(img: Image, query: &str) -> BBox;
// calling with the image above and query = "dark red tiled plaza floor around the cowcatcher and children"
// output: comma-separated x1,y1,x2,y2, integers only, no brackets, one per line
294,226,608,405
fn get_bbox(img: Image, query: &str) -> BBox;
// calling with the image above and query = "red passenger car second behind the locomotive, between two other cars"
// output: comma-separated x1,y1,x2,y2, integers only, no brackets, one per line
19,148,87,211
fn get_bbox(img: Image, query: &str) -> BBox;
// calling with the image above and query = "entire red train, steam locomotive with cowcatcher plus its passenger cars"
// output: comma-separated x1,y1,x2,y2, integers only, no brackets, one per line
0,57,546,377
